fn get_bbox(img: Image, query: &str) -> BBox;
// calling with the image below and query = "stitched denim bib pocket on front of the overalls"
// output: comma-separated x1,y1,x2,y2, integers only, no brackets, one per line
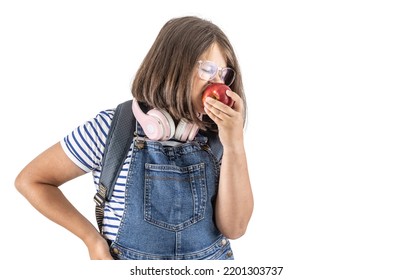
144,163,207,231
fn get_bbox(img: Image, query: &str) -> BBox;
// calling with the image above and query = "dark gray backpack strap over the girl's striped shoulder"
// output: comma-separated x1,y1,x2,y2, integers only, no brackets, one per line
94,100,136,233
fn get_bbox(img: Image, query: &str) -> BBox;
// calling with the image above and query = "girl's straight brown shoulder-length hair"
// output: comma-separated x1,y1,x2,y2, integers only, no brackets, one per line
132,16,246,129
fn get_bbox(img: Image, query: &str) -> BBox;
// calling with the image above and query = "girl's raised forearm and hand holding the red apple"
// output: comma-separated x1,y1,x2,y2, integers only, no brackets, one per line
205,91,254,239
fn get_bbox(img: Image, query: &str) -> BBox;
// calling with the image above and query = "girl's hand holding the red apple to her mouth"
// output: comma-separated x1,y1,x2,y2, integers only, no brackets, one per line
204,90,244,148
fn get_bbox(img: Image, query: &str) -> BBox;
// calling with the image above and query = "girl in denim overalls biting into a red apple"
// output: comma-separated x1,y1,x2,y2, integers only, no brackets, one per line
15,17,253,260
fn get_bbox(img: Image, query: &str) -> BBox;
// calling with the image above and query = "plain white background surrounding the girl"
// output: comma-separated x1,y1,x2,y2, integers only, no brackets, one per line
0,0,413,280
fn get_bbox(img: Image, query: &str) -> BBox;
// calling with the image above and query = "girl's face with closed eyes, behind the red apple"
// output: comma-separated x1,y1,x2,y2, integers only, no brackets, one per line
191,44,227,114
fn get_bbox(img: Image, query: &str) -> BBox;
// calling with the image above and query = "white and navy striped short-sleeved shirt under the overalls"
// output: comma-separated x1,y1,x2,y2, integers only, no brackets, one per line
60,109,133,241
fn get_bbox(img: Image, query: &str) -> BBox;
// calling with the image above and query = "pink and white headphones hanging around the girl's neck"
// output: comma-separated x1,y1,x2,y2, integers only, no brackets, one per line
132,98,199,141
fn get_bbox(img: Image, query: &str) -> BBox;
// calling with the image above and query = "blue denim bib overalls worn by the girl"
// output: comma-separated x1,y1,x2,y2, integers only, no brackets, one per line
110,124,233,260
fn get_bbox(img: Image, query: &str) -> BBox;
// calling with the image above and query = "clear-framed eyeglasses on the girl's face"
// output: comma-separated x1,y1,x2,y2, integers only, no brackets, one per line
198,60,235,86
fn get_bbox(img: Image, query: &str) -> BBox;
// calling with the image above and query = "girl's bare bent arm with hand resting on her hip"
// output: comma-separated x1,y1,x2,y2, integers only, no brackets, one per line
15,143,112,259
